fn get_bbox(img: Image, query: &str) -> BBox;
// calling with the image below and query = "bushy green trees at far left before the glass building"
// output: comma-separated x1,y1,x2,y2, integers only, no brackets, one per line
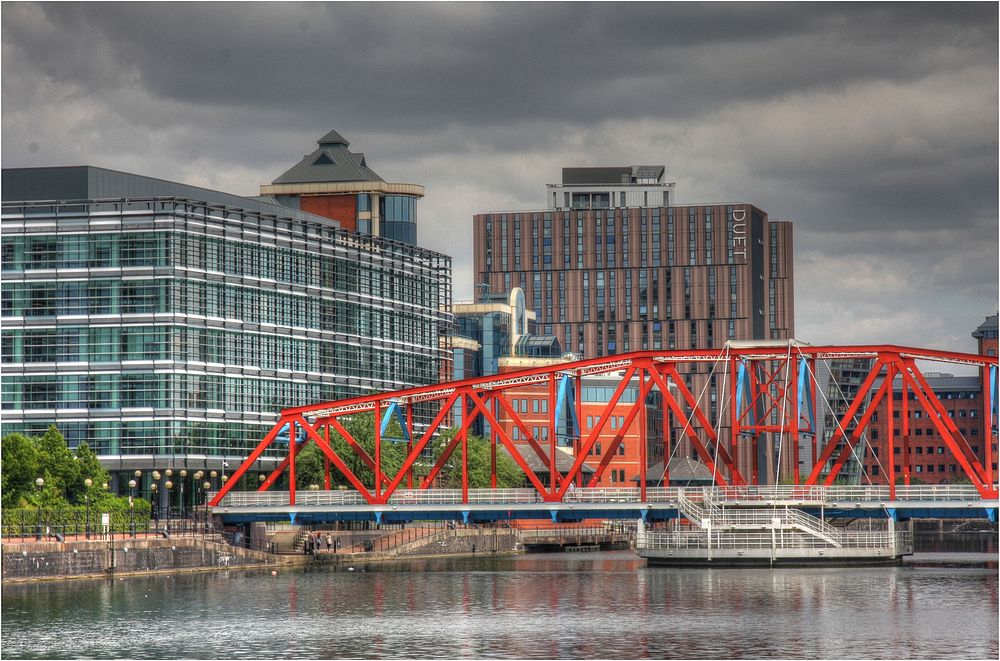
2,426,115,509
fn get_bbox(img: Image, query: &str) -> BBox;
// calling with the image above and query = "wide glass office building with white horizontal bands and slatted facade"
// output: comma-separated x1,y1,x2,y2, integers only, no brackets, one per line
2,166,452,485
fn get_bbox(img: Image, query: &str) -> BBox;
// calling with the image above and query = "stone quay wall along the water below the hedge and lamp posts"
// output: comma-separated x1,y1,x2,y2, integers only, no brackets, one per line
2,537,302,581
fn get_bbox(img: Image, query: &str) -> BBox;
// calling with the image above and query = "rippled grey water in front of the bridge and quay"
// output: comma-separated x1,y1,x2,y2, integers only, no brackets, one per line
0,553,998,659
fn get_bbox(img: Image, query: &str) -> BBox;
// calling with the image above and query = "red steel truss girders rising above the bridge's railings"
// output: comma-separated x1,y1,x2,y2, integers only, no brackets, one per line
211,341,998,506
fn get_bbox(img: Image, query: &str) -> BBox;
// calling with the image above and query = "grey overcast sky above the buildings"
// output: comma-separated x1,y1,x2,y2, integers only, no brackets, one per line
2,2,998,360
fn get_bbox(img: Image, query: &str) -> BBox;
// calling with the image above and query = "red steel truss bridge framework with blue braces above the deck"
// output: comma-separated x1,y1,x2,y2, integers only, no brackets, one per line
210,340,998,509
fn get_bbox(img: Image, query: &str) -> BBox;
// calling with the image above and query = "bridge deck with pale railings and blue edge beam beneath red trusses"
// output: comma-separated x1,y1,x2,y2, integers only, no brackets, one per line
212,485,998,522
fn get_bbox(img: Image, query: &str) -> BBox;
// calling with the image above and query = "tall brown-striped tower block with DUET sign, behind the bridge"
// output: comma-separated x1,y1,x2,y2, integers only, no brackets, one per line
474,166,794,479
